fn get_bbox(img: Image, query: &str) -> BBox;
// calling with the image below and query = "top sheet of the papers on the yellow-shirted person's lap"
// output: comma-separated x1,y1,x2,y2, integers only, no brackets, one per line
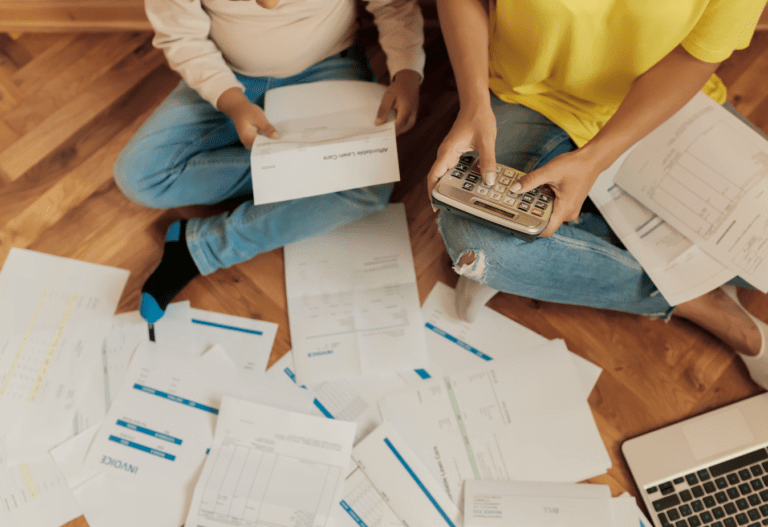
615,93,768,293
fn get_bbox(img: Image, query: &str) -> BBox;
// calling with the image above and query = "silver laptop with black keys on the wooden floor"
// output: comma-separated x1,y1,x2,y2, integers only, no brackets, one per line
621,393,768,527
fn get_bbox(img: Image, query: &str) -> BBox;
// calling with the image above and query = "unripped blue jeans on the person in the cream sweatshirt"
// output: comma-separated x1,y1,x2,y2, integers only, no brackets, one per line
114,46,393,274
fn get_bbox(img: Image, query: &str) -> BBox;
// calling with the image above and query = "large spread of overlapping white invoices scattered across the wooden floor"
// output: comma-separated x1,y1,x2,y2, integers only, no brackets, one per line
0,212,610,527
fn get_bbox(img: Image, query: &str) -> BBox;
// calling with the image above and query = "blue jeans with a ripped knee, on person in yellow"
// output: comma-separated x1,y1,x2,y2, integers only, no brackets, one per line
438,96,751,318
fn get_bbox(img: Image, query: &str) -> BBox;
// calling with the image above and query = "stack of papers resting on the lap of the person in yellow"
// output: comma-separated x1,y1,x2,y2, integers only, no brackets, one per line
589,93,768,305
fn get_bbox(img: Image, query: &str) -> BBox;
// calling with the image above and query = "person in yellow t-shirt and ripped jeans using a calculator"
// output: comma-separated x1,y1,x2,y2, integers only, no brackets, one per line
427,0,768,388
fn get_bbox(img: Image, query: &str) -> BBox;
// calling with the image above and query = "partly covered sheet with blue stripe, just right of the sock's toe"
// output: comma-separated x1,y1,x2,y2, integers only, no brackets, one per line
190,309,277,380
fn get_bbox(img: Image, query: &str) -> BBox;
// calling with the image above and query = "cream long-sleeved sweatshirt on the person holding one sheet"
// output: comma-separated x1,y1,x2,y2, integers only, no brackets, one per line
145,0,425,106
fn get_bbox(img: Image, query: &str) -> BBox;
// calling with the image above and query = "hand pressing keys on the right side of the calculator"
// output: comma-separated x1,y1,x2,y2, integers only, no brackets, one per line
510,150,601,238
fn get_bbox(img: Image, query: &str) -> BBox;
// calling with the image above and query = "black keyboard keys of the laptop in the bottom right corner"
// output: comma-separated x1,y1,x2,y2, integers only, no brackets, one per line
645,448,768,527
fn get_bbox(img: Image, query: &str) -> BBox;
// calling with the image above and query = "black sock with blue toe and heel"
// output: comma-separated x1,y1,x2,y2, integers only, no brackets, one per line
139,220,200,324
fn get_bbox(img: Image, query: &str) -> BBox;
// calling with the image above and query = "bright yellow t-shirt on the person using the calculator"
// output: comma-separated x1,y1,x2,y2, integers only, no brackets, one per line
490,0,765,146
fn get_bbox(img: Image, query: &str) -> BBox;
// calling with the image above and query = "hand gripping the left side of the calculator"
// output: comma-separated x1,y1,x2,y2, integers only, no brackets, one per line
427,100,496,209
